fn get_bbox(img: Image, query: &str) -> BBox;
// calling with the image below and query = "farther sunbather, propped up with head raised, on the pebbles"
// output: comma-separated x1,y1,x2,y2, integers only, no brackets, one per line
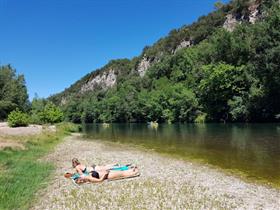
72,158,128,176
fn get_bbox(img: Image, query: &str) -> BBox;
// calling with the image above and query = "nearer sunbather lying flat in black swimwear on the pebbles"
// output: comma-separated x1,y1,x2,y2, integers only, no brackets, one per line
64,167,140,184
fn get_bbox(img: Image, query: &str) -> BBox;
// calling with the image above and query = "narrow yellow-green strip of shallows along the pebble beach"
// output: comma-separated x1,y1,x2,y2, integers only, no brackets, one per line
81,135,280,190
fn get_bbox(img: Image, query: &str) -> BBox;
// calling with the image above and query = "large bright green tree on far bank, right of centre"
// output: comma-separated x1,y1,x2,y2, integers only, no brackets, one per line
199,63,250,121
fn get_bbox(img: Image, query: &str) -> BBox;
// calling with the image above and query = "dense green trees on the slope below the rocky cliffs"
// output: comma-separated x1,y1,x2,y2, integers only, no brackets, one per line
58,1,280,122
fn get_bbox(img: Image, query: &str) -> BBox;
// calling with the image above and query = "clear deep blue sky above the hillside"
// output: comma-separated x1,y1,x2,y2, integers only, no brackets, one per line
0,0,228,98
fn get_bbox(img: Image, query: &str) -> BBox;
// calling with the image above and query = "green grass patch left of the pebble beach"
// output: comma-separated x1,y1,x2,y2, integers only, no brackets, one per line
0,123,78,209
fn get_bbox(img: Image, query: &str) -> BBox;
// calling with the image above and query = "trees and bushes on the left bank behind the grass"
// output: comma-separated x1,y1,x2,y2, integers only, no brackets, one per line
0,65,64,127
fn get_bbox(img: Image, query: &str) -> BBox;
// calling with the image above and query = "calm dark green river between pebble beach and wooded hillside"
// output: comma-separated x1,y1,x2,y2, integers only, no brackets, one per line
83,124,280,187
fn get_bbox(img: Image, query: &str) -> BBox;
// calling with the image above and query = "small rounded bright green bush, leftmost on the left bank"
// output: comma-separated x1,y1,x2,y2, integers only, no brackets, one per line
8,109,29,127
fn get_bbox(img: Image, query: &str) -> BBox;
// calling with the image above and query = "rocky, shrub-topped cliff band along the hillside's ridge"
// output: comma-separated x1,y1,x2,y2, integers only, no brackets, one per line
51,0,270,104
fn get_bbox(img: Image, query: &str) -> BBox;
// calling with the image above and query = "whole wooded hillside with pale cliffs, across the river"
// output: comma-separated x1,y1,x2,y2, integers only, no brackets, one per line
49,0,280,122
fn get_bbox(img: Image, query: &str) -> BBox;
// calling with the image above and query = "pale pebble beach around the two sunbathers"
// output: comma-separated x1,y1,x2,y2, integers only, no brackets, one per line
32,136,280,210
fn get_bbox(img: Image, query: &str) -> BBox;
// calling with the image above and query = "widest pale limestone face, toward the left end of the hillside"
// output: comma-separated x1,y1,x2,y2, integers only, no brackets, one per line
81,69,117,93
